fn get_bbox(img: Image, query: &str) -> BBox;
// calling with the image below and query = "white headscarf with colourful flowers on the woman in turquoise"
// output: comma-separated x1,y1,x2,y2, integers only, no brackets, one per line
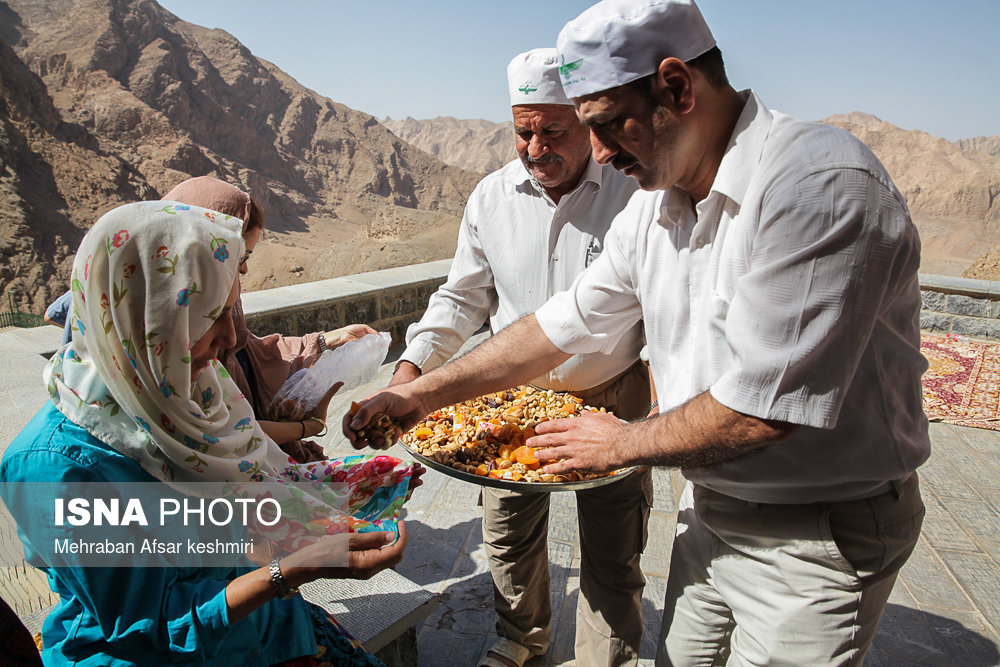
45,201,289,483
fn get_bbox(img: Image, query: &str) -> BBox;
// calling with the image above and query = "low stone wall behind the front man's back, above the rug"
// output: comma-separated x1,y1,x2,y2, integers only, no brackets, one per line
920,274,1000,340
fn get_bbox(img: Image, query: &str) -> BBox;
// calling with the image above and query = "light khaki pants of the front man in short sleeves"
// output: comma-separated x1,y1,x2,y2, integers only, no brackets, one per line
656,474,924,667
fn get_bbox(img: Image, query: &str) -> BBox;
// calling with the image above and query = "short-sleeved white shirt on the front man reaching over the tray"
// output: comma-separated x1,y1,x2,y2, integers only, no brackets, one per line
536,93,930,503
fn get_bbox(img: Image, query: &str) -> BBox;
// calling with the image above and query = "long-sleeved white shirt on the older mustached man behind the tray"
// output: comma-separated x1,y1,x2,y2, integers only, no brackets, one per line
401,160,642,391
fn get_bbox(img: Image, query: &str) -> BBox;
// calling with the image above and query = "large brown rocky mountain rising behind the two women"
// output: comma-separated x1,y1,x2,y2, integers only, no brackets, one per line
0,0,481,312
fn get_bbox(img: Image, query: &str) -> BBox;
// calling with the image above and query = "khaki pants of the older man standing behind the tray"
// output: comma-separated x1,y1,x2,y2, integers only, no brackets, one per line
483,364,653,666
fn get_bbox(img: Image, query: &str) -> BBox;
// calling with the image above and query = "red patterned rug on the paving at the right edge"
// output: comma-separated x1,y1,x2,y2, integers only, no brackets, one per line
920,333,1000,430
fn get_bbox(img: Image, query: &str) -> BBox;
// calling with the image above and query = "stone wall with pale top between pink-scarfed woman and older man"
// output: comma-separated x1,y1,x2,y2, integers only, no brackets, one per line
243,259,451,345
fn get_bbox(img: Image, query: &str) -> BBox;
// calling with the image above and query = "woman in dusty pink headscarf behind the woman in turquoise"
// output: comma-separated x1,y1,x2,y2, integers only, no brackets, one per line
163,176,377,463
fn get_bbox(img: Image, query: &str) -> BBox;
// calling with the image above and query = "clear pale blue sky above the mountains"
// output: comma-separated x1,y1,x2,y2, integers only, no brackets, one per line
159,0,1000,141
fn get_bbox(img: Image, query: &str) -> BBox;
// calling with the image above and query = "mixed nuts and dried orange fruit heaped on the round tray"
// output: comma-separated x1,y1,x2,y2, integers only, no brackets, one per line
402,386,614,483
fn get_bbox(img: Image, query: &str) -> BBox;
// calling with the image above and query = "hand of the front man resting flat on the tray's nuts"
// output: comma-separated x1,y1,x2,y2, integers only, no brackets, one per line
524,412,629,474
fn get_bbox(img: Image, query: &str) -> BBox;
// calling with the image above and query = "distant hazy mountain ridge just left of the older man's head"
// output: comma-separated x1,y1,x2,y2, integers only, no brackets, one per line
382,116,517,174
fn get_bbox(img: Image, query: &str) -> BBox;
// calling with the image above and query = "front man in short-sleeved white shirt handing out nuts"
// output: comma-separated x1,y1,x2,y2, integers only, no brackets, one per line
345,0,929,665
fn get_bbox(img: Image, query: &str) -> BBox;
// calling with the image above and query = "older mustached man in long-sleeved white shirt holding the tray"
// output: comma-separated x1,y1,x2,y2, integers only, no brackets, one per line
390,48,652,665
